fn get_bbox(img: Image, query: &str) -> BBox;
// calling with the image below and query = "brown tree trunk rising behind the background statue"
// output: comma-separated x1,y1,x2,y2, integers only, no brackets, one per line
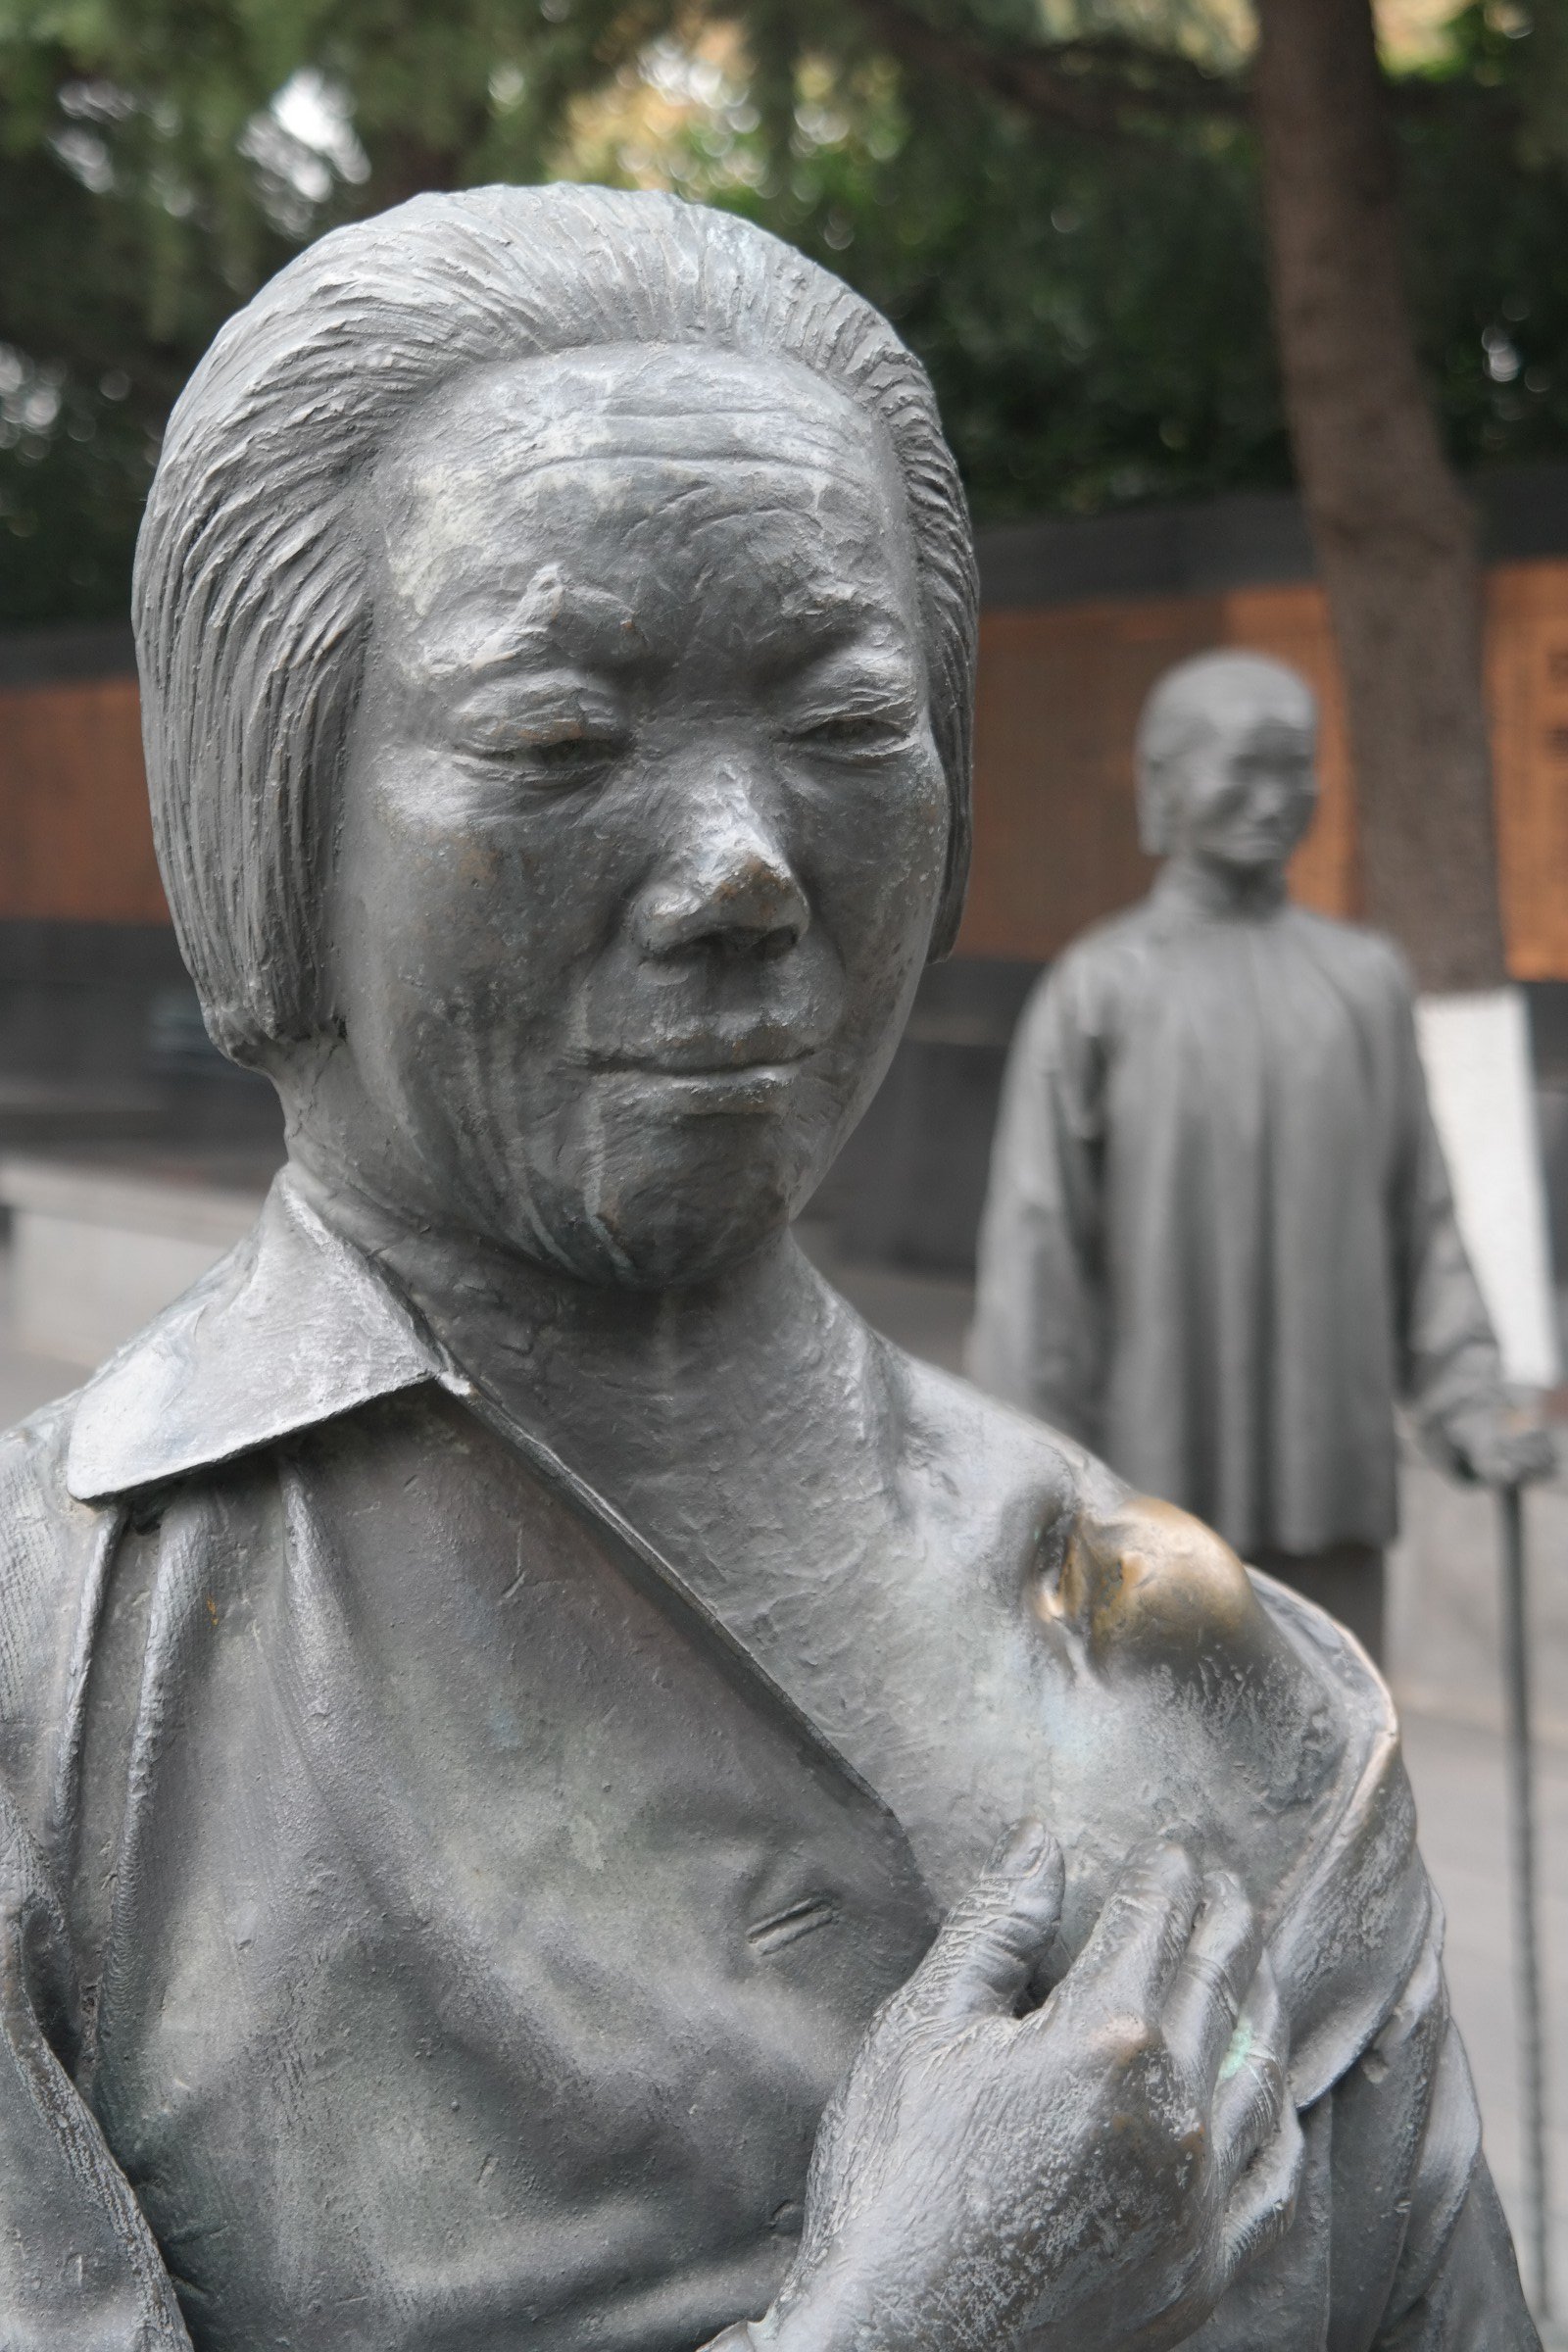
1253,0,1507,990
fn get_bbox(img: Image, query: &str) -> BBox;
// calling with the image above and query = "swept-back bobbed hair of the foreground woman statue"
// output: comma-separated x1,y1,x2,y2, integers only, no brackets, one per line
134,186,978,1063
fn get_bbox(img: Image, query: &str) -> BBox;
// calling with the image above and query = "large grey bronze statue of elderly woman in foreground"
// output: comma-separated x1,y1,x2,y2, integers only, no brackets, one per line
0,188,1535,2352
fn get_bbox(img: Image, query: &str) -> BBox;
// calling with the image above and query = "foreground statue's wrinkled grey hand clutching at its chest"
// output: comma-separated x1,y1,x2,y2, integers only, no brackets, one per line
748,1823,1300,2352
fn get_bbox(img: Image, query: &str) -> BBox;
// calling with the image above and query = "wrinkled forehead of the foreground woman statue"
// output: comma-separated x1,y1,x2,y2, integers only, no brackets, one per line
371,346,921,665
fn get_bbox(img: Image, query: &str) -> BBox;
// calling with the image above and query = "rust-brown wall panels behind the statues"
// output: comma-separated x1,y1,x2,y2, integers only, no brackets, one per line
0,563,1568,981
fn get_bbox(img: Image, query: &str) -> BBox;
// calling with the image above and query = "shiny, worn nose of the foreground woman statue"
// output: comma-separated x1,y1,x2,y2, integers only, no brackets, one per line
635,781,811,957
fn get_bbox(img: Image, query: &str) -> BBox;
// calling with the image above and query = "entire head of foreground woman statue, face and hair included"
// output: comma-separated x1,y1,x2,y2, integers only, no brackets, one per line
136,188,976,1287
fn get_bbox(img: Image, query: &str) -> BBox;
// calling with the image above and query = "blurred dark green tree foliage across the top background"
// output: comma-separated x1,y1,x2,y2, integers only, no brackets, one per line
0,0,1568,625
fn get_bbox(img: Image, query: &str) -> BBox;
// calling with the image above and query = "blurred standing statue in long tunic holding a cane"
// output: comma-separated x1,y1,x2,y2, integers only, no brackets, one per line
971,654,1551,1658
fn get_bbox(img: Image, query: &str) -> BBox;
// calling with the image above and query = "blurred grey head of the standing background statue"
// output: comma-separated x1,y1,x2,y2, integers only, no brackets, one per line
1138,652,1316,894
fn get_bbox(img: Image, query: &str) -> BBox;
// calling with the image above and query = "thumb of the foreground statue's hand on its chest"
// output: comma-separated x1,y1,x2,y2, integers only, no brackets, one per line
901,1821,1062,2018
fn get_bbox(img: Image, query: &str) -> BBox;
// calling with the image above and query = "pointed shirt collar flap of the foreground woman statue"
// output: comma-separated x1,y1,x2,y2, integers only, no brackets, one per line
66,1169,470,1503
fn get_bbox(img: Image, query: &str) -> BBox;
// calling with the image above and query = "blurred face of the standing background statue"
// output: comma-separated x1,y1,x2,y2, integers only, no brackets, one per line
1163,682,1316,872
